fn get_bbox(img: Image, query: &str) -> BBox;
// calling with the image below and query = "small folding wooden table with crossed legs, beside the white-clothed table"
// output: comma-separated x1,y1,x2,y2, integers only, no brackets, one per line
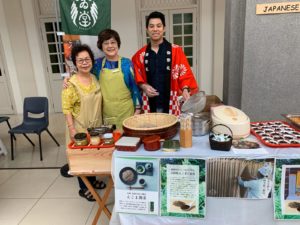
67,147,114,225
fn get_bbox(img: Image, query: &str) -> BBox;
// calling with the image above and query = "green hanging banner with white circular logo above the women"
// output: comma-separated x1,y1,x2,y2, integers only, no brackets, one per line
59,0,111,35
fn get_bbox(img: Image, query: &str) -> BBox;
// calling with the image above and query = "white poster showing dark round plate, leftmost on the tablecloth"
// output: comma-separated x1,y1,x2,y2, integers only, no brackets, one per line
114,157,159,215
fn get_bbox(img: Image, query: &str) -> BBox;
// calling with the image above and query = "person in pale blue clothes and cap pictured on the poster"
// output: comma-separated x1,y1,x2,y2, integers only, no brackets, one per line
238,163,273,199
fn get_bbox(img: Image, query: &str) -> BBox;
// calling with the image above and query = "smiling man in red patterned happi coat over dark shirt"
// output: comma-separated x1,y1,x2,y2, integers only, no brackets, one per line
132,12,198,115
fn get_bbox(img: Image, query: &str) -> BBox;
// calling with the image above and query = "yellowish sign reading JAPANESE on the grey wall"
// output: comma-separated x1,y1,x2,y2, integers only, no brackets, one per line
256,2,300,14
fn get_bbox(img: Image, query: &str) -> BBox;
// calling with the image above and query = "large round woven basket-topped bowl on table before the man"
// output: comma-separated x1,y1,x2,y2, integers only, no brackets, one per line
123,113,179,139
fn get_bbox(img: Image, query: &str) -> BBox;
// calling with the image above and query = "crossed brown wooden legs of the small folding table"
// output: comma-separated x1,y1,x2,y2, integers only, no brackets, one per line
80,176,113,225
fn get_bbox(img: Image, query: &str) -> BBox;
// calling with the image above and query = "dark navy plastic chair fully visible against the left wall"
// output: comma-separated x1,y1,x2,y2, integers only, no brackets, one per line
9,97,60,161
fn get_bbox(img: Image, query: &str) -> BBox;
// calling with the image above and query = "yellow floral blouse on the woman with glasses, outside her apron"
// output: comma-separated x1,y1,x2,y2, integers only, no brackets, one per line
61,75,98,117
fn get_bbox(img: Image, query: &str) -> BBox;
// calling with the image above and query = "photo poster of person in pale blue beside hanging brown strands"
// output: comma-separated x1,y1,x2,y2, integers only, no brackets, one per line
207,158,274,199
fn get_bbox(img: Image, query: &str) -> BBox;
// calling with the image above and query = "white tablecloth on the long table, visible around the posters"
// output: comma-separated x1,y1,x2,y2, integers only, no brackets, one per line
110,135,300,225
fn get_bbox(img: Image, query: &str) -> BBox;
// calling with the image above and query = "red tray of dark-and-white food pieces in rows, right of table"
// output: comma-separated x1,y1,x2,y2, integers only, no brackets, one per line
251,120,300,148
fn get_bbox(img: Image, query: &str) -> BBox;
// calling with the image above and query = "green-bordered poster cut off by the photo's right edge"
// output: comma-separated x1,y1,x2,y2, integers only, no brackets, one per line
274,159,300,220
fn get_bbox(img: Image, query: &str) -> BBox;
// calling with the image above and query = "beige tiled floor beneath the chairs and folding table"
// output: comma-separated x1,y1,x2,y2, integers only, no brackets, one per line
0,114,114,225
